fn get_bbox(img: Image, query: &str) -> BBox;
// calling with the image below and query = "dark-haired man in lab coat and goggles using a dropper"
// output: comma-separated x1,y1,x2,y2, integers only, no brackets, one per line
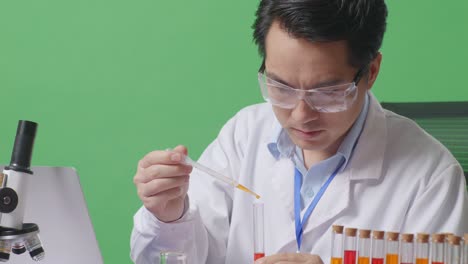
131,0,468,264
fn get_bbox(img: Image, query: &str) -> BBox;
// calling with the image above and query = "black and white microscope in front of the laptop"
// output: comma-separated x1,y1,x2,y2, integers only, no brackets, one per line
0,120,45,262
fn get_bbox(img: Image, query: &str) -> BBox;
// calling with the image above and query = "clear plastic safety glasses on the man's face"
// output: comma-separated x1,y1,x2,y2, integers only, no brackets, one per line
258,68,364,113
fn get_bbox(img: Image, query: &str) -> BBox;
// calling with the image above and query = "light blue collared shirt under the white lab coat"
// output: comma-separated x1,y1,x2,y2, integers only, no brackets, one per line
268,94,369,208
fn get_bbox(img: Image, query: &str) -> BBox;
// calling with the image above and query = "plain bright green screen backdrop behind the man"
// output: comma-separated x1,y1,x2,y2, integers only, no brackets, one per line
0,0,468,263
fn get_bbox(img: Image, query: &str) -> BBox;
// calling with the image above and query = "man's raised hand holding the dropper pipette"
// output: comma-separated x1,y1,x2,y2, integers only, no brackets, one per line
133,146,192,222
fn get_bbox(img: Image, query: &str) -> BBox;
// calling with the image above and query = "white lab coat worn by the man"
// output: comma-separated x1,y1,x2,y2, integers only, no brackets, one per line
131,95,468,264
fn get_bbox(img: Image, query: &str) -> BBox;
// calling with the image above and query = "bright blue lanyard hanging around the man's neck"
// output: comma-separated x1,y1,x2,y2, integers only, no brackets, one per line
294,160,344,251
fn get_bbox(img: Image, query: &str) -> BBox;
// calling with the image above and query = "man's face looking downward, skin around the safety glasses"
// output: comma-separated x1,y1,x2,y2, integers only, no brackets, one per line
265,23,380,155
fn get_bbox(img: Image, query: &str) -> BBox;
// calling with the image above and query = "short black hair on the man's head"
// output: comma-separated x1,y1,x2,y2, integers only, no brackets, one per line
252,0,388,67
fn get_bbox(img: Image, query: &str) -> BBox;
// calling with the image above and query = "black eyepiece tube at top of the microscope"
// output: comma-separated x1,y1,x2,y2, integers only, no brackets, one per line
7,120,37,174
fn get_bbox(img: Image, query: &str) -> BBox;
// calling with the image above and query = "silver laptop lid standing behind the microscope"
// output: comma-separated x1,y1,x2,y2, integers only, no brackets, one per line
0,166,103,264
